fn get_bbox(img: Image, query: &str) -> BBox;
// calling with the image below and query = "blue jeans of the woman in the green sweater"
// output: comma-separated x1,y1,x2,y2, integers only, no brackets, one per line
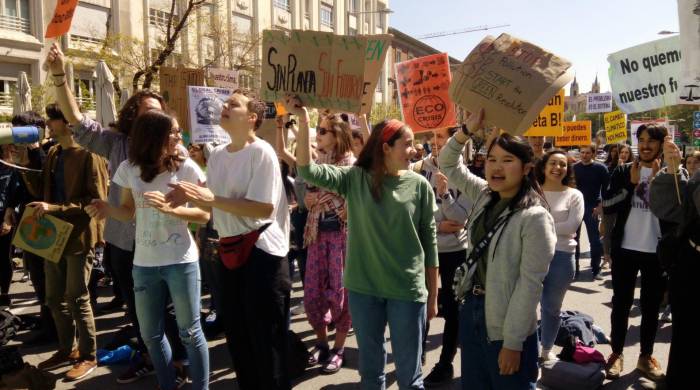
349,291,426,390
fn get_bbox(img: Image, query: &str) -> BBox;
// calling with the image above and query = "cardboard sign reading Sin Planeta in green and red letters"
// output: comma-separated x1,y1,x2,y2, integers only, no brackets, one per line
261,30,367,112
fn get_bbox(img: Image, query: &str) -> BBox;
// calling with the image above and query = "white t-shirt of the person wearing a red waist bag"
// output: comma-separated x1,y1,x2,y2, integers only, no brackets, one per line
207,139,289,256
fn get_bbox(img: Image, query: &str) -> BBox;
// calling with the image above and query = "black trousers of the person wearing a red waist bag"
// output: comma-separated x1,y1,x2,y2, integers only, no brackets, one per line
219,247,291,390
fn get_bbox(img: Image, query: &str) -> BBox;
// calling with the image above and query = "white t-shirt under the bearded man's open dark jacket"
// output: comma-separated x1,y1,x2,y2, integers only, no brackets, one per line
622,167,661,253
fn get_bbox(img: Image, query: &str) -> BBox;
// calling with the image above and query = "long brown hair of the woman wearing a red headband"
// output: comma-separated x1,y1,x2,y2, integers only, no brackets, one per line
355,120,408,202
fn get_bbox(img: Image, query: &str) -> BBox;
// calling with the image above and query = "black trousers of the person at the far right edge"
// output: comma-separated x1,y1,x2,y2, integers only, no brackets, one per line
666,241,700,389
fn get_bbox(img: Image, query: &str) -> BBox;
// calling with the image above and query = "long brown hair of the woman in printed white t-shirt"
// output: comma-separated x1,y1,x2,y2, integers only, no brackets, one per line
129,110,182,183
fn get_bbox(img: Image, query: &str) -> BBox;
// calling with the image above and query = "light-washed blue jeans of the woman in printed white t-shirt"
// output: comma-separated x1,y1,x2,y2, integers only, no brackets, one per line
133,262,209,390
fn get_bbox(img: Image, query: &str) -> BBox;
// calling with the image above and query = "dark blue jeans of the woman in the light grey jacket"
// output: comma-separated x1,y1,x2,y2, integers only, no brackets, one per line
459,296,537,390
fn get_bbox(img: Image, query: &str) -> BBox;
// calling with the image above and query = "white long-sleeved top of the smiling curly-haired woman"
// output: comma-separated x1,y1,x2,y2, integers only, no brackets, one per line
544,188,584,253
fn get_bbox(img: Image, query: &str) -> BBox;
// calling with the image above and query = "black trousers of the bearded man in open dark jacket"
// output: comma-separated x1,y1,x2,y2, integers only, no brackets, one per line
610,248,664,355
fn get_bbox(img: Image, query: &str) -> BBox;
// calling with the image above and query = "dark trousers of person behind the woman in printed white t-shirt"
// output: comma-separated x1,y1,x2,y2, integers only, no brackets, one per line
107,244,187,360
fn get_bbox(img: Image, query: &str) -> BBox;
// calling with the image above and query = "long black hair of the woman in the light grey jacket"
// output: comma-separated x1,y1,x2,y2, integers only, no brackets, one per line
486,133,547,210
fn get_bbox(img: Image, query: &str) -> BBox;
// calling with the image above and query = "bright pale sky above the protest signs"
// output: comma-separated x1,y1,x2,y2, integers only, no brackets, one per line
389,0,678,95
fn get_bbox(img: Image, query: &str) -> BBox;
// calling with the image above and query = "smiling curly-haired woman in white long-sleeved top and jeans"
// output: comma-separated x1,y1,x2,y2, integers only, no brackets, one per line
535,149,583,361
